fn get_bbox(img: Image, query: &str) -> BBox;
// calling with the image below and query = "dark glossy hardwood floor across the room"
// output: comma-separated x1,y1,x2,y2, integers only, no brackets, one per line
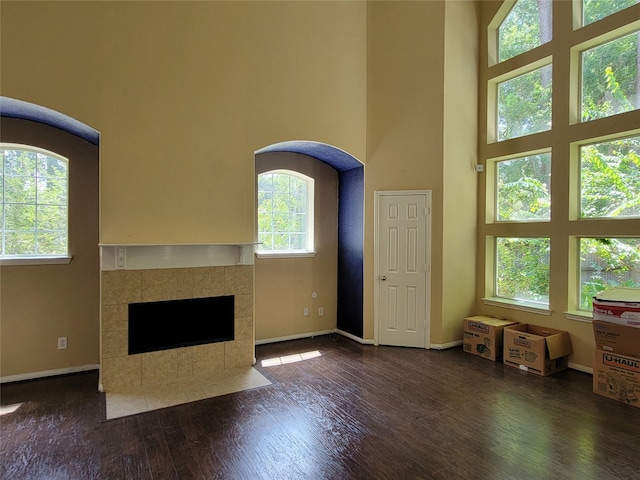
0,336,640,480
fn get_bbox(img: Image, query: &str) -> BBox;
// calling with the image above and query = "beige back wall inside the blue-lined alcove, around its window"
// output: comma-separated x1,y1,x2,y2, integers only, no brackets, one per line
255,153,338,340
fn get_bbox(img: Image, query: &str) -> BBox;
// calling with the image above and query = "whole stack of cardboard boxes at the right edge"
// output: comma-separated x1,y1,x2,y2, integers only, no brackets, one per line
593,288,640,407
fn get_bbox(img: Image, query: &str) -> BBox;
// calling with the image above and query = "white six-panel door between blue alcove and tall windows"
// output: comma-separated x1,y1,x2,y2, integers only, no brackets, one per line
376,192,431,348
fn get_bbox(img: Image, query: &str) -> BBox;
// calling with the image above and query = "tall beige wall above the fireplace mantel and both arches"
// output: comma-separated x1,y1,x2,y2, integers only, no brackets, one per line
1,1,366,248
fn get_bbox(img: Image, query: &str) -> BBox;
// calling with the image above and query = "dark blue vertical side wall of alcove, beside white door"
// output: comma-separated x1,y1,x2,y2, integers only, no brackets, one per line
337,167,364,338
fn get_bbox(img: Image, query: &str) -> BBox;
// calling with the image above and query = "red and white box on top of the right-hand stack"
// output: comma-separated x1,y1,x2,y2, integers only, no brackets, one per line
593,287,640,328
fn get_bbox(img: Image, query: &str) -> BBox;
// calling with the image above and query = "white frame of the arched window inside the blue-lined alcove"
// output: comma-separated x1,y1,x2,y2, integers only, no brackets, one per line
255,168,317,259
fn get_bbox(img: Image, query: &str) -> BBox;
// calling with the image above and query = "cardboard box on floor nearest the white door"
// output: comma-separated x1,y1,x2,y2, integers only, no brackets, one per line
462,315,518,361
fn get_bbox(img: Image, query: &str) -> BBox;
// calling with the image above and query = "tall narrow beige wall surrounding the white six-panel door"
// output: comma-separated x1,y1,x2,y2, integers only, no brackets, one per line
364,2,477,345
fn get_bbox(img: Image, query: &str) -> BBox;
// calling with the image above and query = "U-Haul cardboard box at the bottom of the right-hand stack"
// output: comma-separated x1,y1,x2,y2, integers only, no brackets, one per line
593,350,640,407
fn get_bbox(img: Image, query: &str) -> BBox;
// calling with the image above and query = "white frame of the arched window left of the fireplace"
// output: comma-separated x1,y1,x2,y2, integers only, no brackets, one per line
0,142,73,266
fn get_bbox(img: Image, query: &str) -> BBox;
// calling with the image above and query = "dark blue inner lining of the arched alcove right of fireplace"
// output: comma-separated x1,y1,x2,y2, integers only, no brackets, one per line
255,141,364,338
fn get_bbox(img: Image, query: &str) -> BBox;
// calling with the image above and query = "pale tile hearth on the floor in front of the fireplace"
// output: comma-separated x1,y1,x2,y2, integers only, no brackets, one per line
106,367,271,420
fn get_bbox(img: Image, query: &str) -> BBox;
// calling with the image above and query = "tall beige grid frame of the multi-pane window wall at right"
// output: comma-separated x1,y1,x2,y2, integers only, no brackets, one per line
478,0,640,322
